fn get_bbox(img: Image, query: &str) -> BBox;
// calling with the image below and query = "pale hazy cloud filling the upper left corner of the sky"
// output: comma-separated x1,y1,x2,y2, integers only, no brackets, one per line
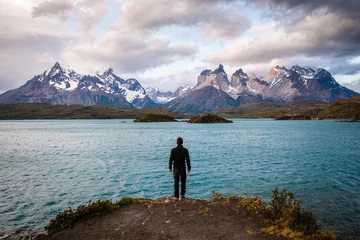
0,1,76,92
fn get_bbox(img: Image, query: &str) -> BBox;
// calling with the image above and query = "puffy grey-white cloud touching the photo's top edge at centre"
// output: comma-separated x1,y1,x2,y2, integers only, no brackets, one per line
115,0,251,38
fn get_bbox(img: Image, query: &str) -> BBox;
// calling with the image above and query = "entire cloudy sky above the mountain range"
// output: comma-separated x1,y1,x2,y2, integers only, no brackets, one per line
0,0,360,93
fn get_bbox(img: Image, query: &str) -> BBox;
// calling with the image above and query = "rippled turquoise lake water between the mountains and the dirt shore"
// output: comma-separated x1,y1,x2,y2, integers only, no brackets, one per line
0,119,360,237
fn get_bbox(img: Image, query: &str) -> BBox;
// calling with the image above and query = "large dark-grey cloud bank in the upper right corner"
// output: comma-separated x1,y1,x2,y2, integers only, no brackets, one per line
205,0,360,74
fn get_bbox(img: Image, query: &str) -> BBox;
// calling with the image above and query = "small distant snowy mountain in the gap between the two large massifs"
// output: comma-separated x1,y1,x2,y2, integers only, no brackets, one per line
145,85,191,104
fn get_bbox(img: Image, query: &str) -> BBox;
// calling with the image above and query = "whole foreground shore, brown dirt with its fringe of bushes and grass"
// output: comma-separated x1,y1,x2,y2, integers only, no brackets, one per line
0,192,337,240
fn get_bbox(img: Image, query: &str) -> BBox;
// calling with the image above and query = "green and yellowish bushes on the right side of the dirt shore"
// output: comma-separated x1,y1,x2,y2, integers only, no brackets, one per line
212,187,337,240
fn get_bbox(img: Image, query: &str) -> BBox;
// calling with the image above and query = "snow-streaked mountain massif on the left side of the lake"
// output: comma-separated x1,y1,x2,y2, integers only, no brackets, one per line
0,62,156,107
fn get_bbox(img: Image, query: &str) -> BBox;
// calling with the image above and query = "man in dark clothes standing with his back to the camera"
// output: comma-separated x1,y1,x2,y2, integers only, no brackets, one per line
169,137,191,200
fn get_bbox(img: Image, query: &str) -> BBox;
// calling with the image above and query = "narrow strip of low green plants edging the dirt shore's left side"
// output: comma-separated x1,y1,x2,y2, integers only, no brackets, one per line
45,198,145,234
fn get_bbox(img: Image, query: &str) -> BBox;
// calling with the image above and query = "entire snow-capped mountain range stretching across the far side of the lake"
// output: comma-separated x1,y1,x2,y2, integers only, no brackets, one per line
0,62,360,113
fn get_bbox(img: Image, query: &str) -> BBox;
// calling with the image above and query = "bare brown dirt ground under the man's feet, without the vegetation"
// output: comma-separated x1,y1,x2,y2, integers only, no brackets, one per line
36,198,281,240
